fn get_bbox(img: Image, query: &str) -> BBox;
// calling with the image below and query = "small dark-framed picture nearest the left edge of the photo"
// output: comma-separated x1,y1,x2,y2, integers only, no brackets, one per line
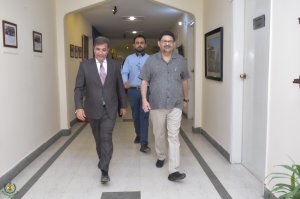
2,20,18,48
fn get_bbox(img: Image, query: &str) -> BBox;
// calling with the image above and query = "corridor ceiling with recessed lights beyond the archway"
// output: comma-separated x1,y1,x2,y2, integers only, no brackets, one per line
80,0,183,39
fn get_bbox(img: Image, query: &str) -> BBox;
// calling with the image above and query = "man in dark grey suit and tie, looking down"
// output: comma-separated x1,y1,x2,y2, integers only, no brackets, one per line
74,37,127,183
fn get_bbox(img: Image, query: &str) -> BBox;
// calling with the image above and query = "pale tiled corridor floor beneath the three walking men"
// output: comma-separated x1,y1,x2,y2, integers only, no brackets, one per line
4,115,263,199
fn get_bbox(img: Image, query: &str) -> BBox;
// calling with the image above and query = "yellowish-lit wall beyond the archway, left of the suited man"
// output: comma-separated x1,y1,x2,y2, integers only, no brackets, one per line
65,13,93,121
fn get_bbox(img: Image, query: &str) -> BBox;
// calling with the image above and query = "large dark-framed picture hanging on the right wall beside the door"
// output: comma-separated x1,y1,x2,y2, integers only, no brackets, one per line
205,27,223,81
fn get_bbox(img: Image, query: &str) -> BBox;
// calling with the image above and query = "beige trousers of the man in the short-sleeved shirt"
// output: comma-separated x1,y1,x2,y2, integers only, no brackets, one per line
150,108,182,173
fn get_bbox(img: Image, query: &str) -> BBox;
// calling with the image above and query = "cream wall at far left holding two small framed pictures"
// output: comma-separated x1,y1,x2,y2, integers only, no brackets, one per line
0,0,61,176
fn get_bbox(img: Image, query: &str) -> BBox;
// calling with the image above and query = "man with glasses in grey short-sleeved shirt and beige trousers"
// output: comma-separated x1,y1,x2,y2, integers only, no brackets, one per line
139,31,190,181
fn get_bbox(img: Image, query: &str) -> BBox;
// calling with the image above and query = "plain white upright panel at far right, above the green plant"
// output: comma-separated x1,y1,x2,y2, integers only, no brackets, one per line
266,0,300,190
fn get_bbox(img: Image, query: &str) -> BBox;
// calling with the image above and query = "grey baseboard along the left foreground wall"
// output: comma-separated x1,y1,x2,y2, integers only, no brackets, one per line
0,129,71,189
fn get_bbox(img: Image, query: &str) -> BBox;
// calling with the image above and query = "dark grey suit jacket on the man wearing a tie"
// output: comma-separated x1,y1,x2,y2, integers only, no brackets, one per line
74,58,127,119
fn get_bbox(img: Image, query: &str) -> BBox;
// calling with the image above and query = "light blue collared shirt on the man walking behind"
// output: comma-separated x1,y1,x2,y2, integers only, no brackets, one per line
122,53,149,87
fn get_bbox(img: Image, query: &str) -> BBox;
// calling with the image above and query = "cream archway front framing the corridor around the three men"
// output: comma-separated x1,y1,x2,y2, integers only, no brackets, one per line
56,0,203,131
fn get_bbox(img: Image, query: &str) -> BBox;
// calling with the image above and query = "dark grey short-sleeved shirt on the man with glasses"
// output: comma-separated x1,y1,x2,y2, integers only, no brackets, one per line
139,52,190,109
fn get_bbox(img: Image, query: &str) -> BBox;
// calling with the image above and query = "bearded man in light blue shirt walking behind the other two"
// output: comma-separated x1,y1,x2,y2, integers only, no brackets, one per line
122,35,150,153
